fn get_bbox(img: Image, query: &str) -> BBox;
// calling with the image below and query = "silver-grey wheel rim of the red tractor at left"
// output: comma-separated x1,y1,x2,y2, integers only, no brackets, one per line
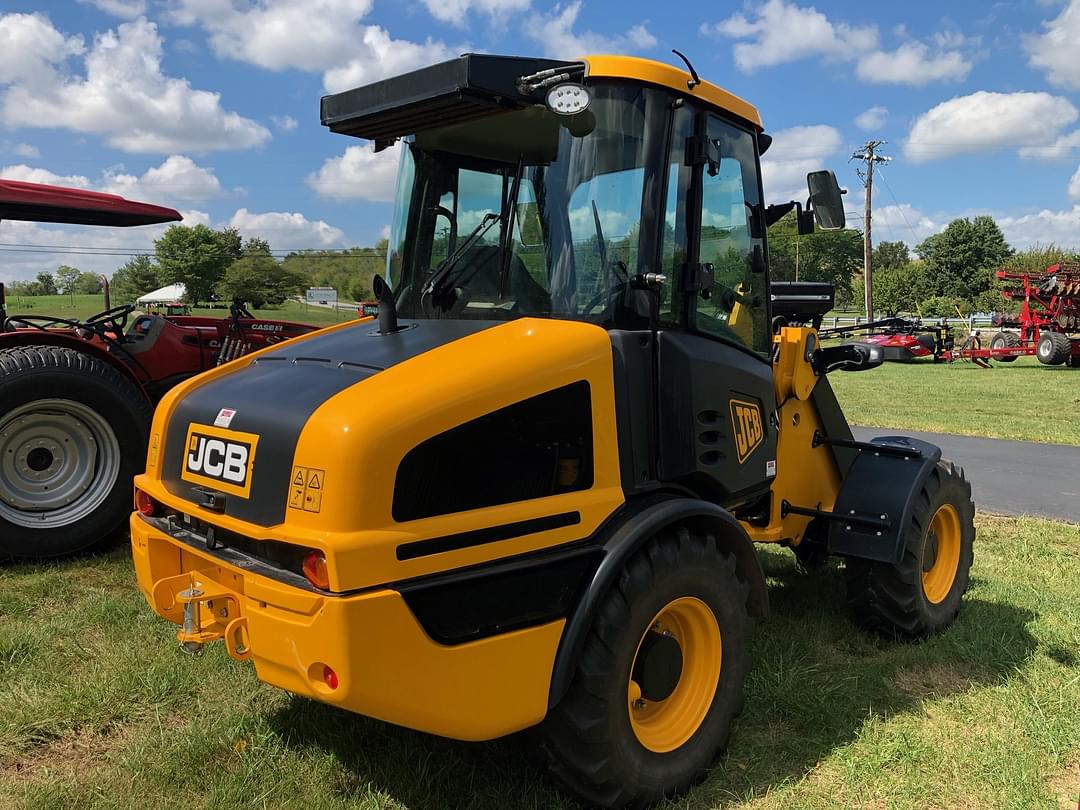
0,400,120,529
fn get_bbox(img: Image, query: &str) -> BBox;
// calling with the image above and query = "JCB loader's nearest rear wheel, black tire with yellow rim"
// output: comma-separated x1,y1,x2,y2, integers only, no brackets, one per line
538,528,753,808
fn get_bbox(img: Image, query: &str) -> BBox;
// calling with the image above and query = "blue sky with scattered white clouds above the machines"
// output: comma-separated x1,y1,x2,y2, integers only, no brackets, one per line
0,0,1080,280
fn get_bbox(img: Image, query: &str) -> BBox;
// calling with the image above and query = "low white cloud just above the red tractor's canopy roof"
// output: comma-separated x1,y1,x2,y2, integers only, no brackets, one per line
0,154,222,205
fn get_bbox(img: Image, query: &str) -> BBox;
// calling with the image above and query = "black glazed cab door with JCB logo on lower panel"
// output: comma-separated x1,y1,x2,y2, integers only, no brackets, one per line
657,110,777,505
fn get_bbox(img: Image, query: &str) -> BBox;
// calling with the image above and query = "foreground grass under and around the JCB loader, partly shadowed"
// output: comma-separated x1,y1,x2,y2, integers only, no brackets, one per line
0,516,1080,810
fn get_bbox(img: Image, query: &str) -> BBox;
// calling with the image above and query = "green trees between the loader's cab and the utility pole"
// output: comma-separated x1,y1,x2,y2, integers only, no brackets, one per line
769,212,863,301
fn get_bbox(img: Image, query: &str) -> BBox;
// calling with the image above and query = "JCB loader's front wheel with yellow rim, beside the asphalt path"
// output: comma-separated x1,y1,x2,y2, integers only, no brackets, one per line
845,461,975,639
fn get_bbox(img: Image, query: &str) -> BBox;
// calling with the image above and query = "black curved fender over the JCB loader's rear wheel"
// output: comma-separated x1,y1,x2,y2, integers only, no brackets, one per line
548,497,769,711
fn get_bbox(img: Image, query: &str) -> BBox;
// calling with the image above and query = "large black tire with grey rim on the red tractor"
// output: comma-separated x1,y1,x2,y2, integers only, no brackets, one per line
0,346,151,559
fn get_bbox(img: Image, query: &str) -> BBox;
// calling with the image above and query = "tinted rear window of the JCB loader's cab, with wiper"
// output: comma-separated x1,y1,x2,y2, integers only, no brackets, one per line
388,85,671,325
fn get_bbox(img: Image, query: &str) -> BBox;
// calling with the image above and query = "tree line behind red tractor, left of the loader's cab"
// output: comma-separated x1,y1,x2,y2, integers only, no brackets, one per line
9,225,387,308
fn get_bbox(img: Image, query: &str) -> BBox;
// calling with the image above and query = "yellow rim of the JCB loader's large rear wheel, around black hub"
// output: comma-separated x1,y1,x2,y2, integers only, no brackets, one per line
626,596,723,754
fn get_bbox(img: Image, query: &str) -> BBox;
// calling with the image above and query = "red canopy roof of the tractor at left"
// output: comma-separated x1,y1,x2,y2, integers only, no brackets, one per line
0,178,184,227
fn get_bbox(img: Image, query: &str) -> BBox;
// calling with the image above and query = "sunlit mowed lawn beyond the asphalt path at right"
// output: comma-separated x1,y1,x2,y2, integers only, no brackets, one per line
828,357,1080,445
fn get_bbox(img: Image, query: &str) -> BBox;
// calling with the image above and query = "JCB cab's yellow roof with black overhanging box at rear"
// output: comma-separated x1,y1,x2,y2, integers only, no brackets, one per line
321,53,761,149
